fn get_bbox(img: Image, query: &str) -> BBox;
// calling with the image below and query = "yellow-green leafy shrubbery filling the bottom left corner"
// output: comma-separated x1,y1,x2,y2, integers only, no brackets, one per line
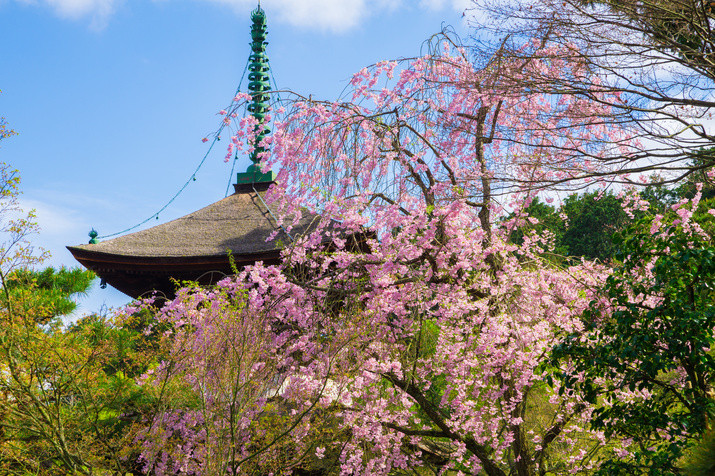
0,310,157,474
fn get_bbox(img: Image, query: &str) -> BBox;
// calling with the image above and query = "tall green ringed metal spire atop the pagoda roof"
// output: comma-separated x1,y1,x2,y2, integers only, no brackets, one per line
236,1,276,185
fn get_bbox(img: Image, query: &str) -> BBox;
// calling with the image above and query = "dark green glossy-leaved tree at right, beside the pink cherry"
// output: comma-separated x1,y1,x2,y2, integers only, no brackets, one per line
553,207,715,475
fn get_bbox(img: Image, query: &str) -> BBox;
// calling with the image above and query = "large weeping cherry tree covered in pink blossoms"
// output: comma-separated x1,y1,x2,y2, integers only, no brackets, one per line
134,38,633,475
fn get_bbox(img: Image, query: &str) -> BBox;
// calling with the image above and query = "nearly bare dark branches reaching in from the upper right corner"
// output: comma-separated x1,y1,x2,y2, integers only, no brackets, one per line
472,0,715,188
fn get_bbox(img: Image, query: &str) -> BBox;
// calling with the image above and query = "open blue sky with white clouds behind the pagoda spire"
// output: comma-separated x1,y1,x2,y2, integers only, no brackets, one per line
0,0,470,312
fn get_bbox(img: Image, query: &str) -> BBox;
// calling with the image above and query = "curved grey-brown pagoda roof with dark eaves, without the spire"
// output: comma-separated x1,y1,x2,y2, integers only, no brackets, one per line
67,184,319,297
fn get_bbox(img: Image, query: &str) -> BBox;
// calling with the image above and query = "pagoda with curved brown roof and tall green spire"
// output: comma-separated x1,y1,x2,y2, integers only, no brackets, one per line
67,4,316,298
